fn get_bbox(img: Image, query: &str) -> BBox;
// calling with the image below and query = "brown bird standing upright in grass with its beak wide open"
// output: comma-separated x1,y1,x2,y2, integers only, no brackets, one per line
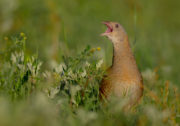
100,21,143,107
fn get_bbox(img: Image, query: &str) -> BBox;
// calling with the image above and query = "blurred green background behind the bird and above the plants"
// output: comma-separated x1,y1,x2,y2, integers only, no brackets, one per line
0,0,180,85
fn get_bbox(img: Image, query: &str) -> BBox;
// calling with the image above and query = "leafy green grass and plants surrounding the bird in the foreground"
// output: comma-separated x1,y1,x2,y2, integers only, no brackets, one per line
0,33,180,126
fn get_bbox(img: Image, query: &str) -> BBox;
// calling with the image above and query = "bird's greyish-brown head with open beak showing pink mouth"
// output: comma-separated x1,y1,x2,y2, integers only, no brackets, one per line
101,21,126,43
